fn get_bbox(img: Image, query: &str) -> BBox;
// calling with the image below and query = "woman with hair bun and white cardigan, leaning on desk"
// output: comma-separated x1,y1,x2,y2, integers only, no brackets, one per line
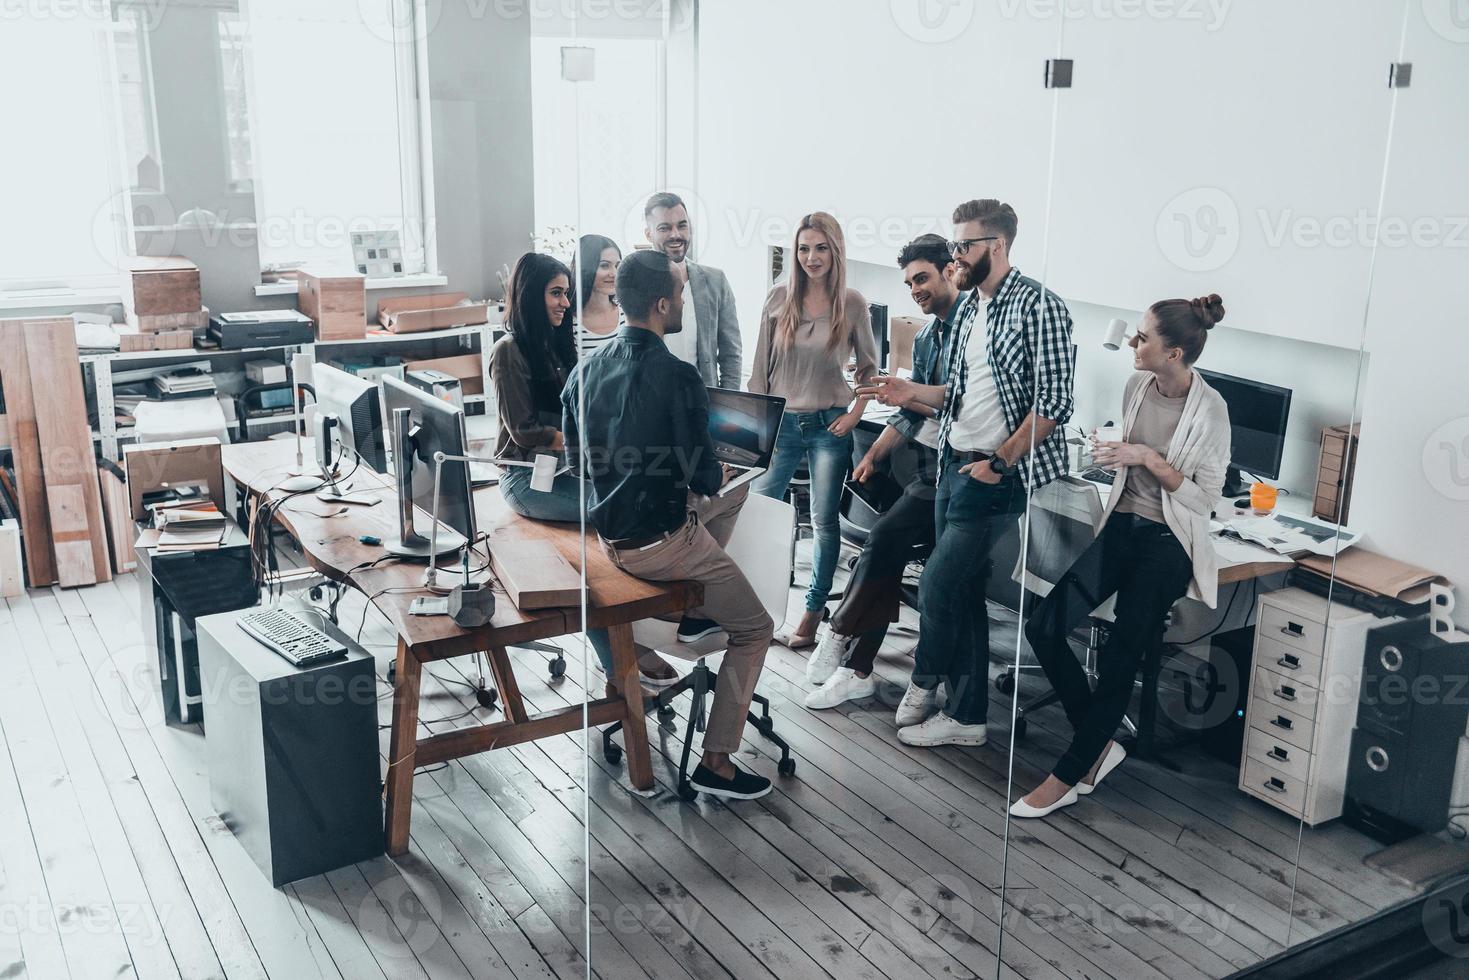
1011,294,1230,817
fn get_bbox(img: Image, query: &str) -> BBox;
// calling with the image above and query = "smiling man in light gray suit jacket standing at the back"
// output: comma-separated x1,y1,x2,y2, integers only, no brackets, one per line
643,191,742,391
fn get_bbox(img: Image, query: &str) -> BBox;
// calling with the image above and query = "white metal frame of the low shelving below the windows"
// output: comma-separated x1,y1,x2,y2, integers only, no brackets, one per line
88,323,499,461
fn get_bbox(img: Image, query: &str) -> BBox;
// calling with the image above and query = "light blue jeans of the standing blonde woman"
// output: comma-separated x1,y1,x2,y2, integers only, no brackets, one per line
751,408,852,613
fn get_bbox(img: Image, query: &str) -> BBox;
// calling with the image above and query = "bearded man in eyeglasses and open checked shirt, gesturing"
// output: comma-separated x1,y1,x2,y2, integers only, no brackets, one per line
858,198,1075,746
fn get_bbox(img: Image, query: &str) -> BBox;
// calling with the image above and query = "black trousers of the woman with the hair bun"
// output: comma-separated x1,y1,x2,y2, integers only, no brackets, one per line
1025,511,1193,786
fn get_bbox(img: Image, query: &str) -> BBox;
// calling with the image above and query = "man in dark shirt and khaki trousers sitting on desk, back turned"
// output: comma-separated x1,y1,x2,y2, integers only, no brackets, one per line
561,251,776,799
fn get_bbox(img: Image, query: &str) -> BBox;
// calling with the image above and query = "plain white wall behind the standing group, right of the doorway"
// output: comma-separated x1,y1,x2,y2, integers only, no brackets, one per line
696,0,1469,623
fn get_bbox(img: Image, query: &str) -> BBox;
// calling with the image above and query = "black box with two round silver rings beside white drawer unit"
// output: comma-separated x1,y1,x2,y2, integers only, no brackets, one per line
1344,619,1469,840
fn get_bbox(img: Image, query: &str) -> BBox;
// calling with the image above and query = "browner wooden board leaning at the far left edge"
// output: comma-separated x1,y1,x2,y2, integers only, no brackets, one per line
0,320,56,589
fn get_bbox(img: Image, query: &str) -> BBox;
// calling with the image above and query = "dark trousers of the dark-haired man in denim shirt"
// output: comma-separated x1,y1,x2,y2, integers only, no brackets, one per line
831,444,937,674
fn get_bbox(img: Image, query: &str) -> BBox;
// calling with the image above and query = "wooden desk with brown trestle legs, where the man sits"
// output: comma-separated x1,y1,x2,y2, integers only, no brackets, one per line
222,439,704,855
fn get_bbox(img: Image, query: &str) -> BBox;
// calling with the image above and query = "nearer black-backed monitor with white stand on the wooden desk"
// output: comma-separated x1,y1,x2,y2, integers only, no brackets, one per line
382,378,474,557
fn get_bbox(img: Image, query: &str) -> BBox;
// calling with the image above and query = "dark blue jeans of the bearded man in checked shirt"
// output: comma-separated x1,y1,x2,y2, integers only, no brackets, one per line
912,463,1025,724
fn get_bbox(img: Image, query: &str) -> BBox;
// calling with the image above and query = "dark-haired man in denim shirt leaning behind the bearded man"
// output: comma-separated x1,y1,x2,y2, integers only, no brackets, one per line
806,235,959,708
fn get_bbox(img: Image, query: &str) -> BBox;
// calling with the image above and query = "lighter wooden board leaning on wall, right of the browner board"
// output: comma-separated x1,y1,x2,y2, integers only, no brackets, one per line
24,317,112,586
